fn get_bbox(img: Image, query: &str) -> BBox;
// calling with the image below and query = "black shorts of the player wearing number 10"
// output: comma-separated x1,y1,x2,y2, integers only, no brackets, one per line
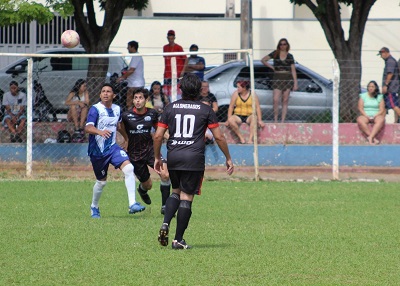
169,170,204,195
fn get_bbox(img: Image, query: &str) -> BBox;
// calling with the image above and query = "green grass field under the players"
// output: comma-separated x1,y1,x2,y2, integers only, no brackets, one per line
0,181,400,285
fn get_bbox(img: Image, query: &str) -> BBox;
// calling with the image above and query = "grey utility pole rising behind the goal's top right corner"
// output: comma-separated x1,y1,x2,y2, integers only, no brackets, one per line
240,0,253,60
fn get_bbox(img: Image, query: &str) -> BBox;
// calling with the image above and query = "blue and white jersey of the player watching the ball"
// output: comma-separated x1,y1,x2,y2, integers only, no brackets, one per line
86,102,121,157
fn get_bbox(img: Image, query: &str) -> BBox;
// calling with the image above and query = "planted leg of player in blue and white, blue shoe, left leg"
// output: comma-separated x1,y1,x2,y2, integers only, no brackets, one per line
90,157,109,218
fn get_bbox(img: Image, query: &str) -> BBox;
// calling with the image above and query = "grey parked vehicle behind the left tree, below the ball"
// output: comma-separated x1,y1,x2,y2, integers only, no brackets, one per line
0,48,127,113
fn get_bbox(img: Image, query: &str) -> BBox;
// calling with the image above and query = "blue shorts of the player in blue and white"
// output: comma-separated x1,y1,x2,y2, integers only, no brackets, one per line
90,144,129,181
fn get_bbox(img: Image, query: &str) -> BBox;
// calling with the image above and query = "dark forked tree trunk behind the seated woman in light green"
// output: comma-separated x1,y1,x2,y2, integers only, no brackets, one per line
290,0,376,122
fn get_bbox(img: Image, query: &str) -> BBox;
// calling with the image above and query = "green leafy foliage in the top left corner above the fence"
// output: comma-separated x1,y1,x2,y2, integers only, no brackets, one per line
0,0,53,26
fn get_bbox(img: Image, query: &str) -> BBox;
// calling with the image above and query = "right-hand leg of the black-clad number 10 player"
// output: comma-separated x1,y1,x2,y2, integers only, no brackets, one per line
172,171,204,249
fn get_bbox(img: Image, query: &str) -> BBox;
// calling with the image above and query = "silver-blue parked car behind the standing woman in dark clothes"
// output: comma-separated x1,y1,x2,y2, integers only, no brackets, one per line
204,60,333,121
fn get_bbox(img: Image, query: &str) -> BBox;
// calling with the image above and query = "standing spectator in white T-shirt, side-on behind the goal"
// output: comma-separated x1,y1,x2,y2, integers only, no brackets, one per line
117,41,144,109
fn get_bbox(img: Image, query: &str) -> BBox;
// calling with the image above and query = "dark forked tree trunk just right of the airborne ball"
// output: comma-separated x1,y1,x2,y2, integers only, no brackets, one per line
48,0,148,104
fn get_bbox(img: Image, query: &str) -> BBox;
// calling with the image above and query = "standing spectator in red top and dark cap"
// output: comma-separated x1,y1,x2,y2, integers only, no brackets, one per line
163,30,186,99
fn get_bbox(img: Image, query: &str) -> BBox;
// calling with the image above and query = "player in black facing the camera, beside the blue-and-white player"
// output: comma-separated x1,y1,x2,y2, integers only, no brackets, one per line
121,89,171,214
